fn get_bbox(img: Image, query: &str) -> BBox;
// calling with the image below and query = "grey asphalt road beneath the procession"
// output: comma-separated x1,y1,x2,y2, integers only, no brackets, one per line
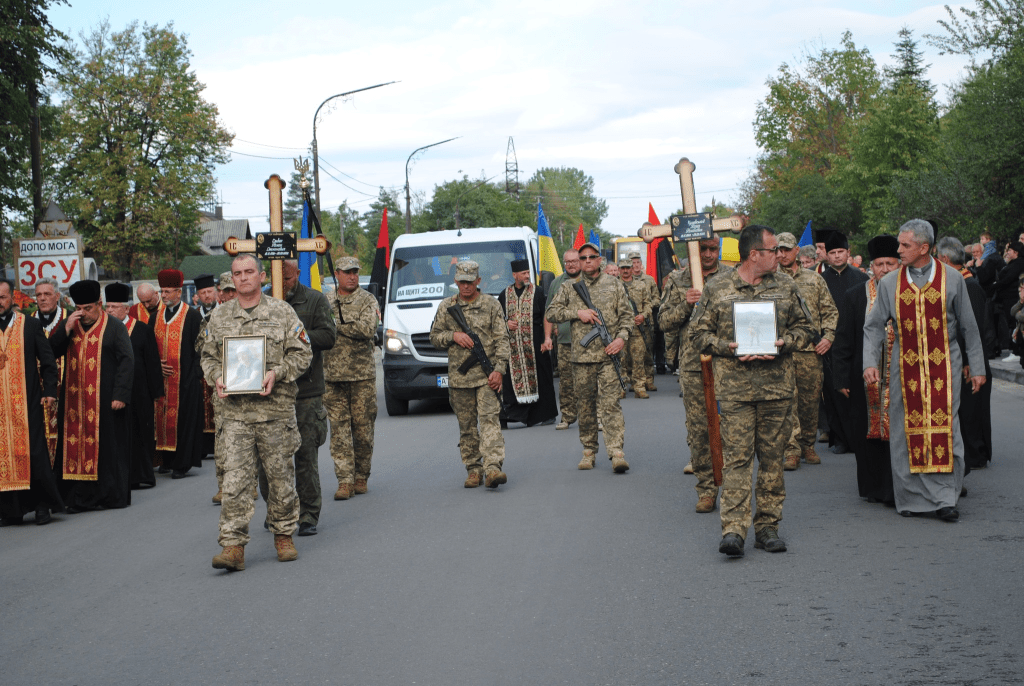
0,377,1024,686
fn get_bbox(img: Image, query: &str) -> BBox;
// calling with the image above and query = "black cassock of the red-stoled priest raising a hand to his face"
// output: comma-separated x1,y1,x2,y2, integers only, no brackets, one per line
50,316,135,511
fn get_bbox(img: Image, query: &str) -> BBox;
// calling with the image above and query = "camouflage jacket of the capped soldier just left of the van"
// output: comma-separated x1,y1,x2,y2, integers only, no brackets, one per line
324,288,380,382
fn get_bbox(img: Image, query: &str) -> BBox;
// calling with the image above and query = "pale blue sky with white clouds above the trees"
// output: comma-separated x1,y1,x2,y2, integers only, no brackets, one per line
50,0,973,235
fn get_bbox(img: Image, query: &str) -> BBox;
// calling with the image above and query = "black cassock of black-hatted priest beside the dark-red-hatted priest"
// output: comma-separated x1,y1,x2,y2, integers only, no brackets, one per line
129,319,164,488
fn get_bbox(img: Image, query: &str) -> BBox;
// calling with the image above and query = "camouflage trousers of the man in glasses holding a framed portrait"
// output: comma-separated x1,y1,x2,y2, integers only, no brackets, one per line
720,398,795,540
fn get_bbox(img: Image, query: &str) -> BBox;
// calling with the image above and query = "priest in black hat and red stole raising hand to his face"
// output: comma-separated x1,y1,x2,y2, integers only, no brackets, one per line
50,281,135,513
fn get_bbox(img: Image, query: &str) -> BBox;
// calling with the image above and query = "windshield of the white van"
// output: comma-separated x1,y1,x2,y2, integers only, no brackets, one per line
388,241,526,302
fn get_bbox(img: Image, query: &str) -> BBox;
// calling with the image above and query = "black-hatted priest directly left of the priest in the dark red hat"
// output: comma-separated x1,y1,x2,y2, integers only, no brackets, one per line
103,284,164,488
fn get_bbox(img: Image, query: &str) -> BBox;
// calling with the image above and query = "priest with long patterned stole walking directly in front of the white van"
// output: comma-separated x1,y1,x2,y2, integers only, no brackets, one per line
498,260,558,426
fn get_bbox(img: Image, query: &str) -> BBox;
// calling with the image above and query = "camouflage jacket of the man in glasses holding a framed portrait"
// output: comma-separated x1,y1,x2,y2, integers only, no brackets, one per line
690,270,810,401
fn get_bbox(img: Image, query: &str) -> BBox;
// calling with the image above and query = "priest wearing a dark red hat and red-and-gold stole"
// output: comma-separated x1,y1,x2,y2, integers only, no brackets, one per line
153,269,203,479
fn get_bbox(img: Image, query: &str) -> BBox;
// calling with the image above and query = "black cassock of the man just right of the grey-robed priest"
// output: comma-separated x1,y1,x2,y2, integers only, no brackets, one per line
956,276,998,473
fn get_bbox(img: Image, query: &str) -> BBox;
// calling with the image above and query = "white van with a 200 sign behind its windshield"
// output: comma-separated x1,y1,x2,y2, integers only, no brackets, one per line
383,226,539,417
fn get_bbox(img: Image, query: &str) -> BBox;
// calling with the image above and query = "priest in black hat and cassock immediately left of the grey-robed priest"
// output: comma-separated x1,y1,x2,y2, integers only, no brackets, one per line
833,235,900,505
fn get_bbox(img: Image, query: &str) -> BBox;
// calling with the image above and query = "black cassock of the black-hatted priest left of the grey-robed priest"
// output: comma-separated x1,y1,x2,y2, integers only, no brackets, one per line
828,284,899,503
